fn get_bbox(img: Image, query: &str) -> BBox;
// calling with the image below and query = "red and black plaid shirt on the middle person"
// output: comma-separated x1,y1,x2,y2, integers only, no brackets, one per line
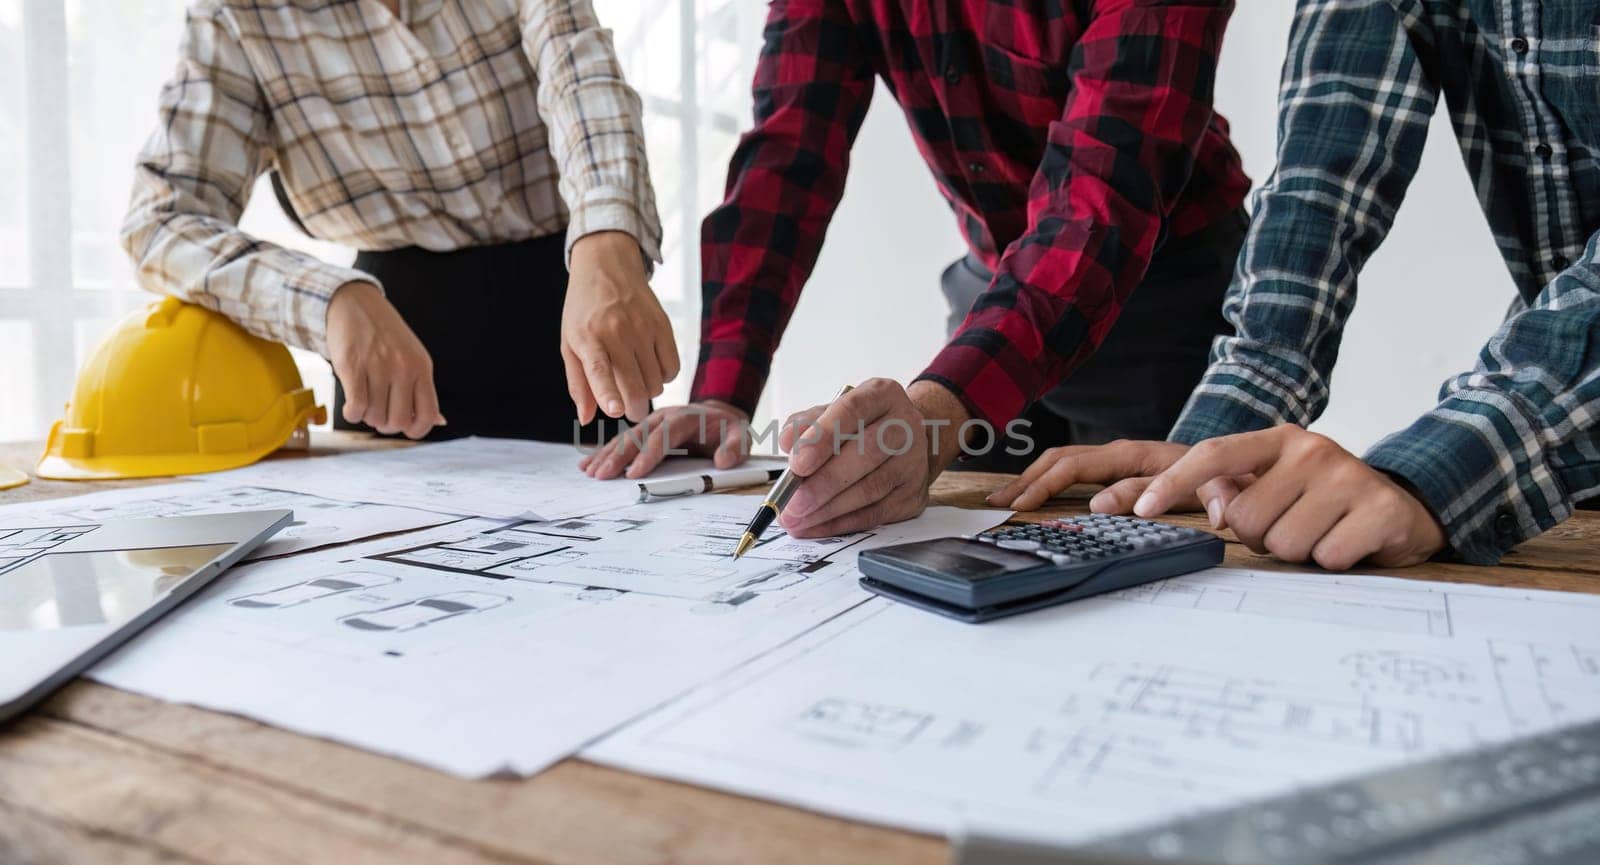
693,0,1250,424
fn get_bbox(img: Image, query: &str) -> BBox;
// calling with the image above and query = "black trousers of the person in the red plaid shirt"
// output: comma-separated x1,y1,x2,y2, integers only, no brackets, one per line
941,209,1248,472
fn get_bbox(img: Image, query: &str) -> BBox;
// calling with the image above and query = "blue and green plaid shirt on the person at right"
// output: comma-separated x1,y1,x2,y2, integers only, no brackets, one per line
1171,0,1600,563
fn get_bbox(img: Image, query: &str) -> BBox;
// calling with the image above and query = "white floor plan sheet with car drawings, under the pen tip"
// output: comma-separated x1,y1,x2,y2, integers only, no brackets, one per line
91,496,1008,775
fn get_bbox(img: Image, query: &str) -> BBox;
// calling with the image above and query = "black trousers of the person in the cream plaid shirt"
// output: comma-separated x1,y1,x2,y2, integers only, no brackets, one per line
333,235,616,443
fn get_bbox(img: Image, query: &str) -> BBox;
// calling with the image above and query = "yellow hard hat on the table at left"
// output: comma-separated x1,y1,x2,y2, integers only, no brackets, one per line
37,297,326,480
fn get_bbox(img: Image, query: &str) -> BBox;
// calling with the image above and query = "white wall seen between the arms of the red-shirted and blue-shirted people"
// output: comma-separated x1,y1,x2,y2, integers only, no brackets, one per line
763,3,1512,451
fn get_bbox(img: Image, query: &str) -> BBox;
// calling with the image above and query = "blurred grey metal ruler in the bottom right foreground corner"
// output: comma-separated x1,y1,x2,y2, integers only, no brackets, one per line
955,721,1600,865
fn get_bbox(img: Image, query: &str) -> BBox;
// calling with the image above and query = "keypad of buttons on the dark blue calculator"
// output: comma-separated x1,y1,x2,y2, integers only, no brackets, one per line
974,513,1211,564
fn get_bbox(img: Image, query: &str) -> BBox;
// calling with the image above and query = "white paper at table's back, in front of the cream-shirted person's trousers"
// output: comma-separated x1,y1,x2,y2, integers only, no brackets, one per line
216,438,782,520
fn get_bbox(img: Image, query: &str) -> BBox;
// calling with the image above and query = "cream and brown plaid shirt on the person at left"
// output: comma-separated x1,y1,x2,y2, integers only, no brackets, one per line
123,0,661,353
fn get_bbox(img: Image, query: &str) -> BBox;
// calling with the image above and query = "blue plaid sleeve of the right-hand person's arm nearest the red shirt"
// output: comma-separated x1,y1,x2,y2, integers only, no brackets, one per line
1171,0,1437,443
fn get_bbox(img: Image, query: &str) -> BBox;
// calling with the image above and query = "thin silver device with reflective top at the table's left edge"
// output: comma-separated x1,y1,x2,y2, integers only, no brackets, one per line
0,510,294,723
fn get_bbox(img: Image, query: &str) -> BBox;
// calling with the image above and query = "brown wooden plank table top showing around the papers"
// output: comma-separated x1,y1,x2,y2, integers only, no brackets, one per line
0,435,1600,865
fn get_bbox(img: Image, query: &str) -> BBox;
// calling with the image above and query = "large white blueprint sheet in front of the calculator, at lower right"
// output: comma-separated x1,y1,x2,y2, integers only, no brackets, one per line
584,569,1600,843
